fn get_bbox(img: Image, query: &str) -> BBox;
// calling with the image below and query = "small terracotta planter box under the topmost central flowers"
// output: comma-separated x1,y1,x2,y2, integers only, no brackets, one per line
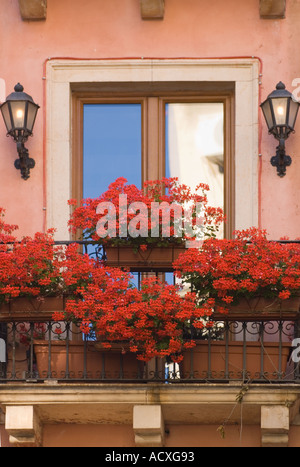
105,245,185,272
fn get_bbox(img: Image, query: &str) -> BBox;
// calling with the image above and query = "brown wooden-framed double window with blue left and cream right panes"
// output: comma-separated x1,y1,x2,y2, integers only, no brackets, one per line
72,88,234,235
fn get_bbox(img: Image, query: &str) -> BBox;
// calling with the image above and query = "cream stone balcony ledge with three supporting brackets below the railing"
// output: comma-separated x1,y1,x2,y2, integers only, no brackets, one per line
0,386,300,447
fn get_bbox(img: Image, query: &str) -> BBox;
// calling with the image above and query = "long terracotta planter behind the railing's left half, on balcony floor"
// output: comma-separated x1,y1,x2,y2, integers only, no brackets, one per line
34,340,143,380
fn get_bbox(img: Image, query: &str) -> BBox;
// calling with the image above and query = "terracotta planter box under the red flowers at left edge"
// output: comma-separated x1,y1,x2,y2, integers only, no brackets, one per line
0,296,66,322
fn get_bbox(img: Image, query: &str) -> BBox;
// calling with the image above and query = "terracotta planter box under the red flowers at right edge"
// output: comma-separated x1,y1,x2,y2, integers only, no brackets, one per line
212,297,300,321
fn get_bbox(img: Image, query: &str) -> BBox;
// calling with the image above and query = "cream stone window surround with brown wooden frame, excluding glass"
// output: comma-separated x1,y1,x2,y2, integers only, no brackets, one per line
44,58,259,240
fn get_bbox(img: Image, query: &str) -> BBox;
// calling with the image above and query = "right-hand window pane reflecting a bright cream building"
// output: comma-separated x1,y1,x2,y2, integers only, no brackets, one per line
166,103,224,216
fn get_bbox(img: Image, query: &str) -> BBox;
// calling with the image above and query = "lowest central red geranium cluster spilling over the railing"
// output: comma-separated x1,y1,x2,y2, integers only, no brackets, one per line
54,265,209,362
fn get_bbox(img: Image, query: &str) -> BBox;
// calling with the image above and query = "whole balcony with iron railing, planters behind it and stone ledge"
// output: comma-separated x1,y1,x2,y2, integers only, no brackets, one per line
0,242,300,446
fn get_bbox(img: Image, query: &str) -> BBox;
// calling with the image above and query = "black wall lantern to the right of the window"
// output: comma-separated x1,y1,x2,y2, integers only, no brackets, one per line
261,82,299,177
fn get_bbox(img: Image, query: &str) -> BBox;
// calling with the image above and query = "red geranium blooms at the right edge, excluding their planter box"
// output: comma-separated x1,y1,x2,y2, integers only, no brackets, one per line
174,228,300,312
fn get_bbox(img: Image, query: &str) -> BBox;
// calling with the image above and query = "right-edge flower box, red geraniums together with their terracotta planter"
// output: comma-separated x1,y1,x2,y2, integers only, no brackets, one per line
174,227,300,321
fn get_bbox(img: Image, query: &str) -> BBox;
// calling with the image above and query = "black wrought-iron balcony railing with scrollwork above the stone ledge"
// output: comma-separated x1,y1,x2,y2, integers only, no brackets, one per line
0,321,300,384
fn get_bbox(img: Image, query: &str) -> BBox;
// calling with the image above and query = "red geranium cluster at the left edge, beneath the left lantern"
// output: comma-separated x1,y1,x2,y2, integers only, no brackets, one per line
0,209,96,303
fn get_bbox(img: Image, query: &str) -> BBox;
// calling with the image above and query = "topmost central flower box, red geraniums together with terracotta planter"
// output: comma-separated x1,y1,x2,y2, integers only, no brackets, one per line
69,177,224,272
